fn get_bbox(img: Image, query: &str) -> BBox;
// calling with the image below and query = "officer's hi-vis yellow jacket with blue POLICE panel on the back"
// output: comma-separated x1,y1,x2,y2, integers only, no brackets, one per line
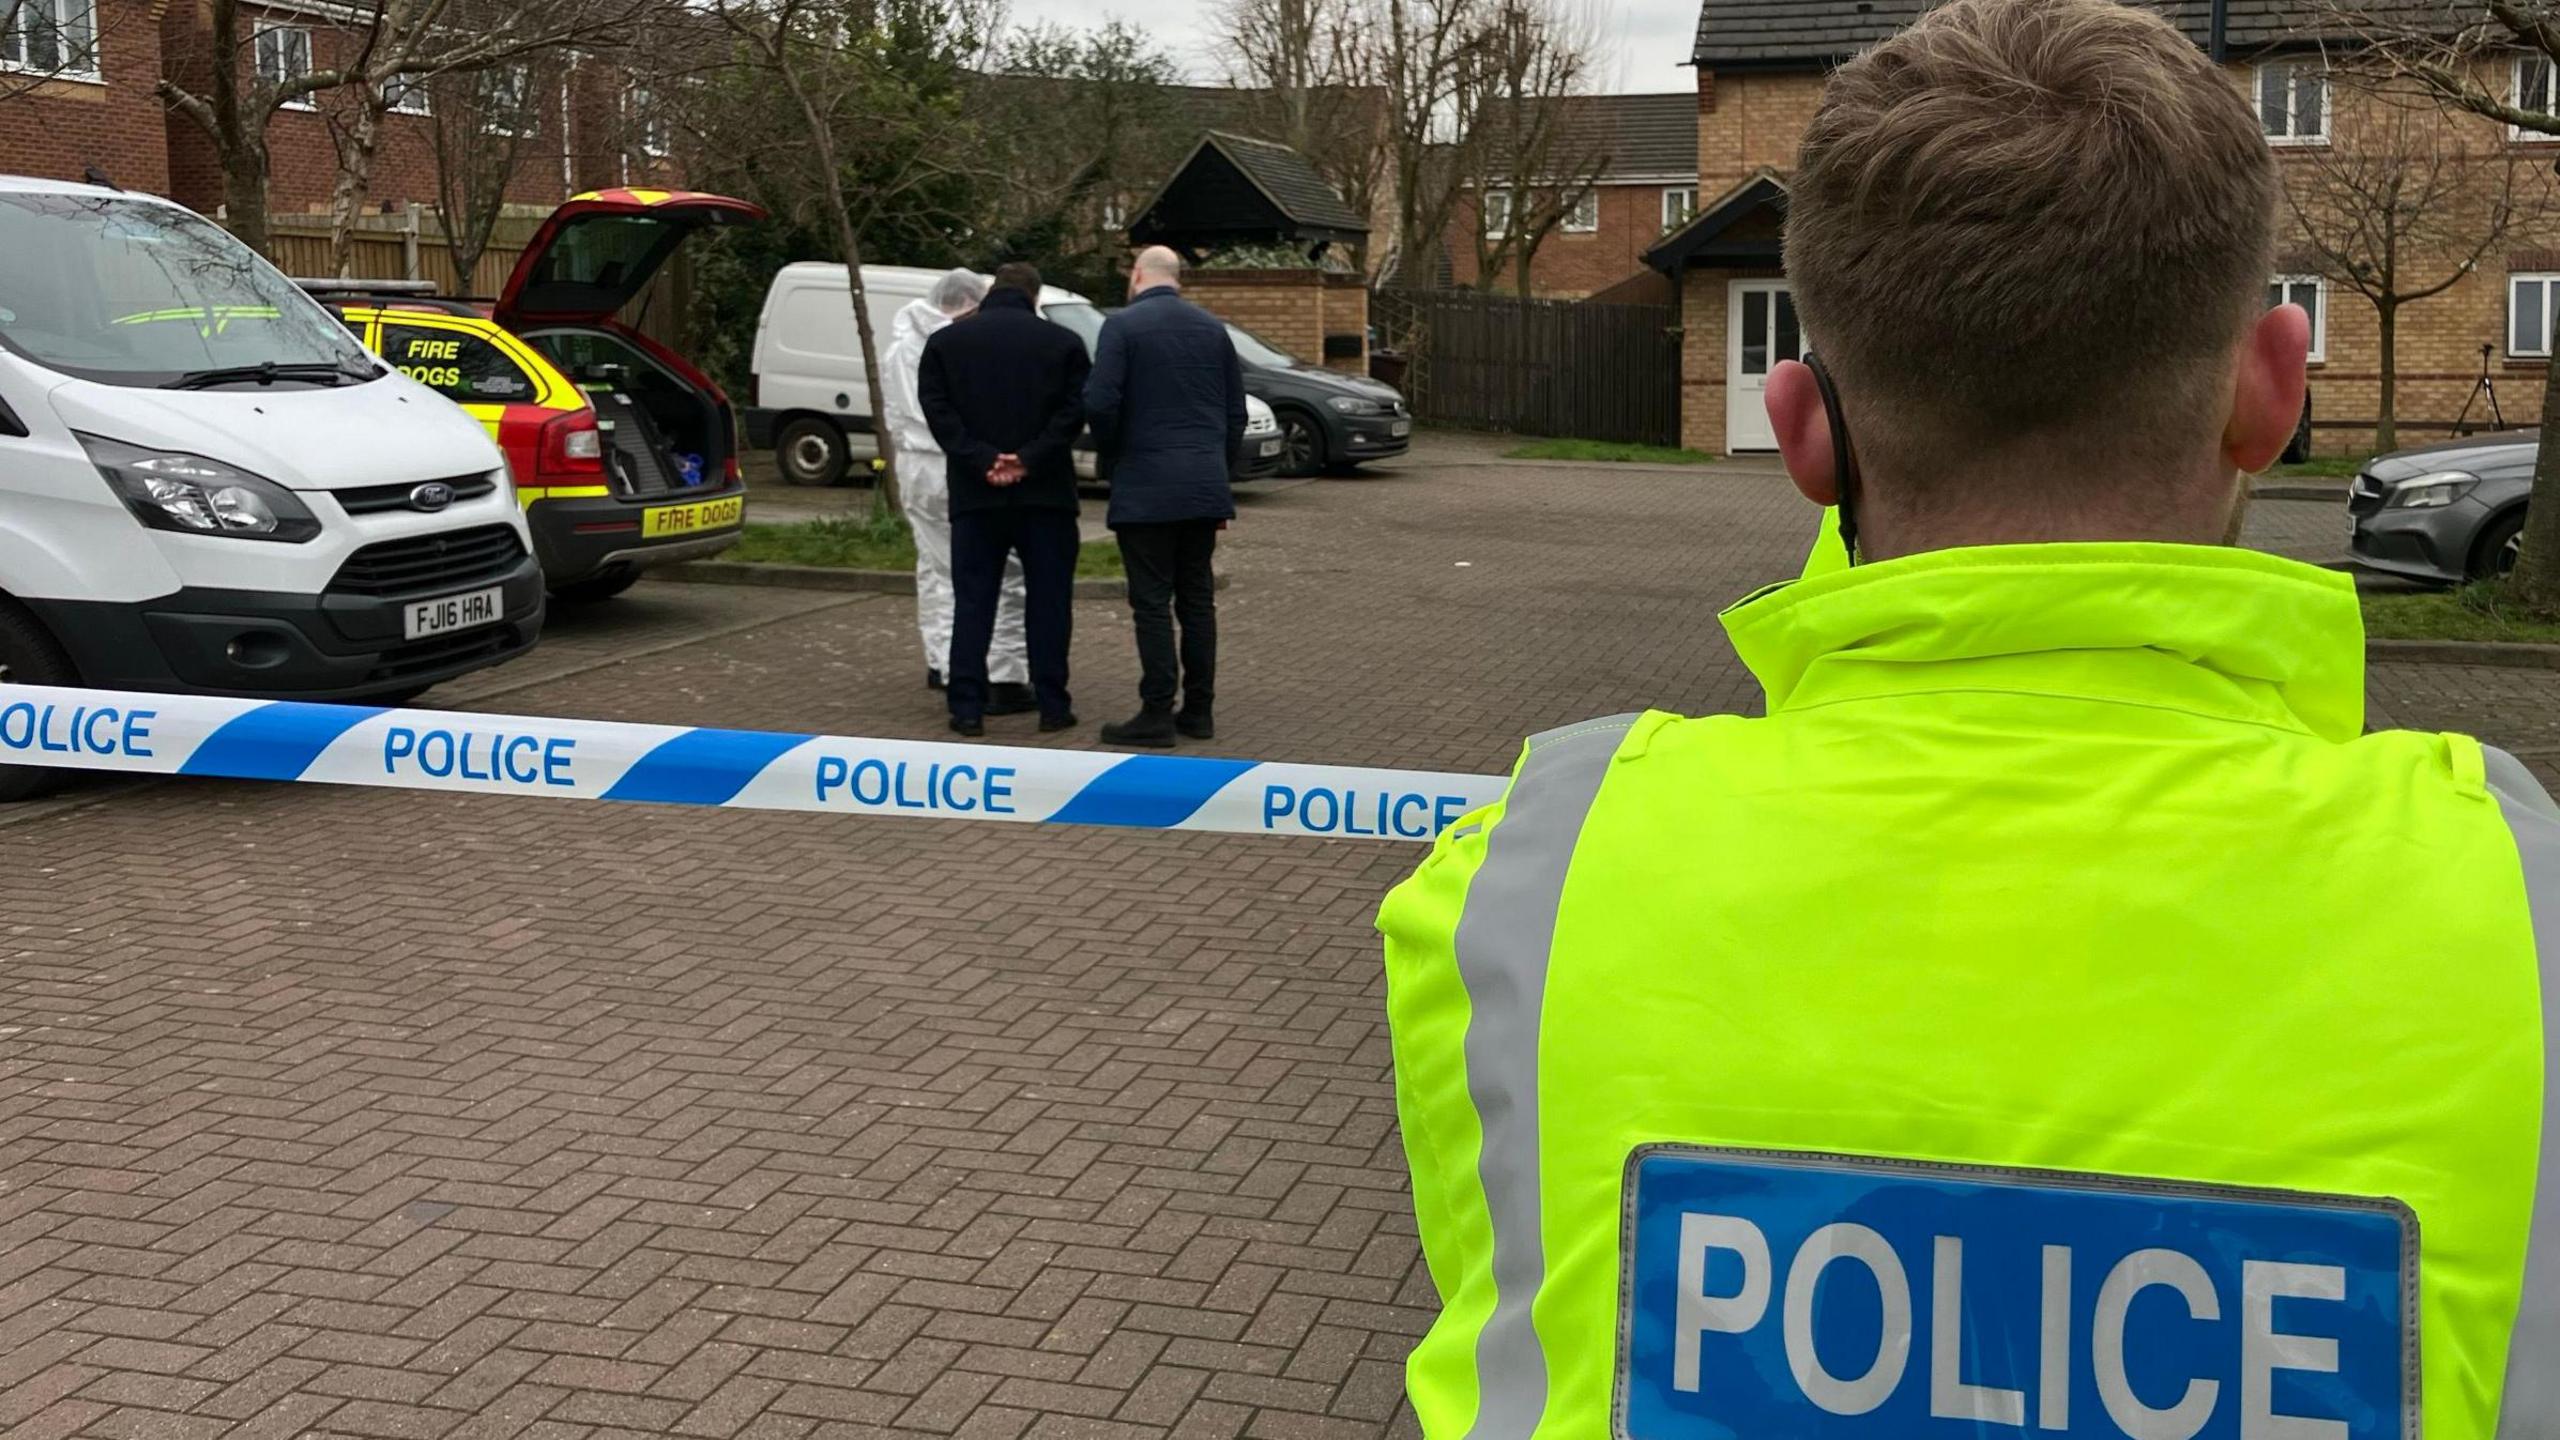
1380,541,2560,1440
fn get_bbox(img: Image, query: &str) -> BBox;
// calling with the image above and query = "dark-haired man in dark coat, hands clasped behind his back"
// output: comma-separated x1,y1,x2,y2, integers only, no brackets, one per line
916,264,1093,735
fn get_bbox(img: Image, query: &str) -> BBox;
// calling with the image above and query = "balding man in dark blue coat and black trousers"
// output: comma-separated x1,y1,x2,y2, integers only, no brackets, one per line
1085,246,1244,746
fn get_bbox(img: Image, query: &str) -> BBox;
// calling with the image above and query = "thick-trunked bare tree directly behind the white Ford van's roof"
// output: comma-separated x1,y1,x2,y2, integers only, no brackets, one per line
159,0,645,264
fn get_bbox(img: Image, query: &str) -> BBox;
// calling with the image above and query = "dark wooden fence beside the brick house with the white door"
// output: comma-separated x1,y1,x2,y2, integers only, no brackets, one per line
1370,290,1679,446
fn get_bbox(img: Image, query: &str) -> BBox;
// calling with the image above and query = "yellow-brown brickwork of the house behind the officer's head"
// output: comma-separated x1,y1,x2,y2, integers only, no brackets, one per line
1679,64,2560,454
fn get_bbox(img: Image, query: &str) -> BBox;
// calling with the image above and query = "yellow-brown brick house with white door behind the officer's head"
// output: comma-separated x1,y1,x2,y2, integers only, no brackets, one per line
1646,0,2560,454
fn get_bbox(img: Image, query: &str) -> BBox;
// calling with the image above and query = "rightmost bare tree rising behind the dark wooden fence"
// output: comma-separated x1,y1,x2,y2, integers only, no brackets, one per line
1457,0,1613,300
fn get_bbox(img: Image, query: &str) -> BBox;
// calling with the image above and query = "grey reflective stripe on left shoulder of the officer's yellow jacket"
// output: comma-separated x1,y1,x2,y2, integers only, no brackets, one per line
1457,715,1636,1440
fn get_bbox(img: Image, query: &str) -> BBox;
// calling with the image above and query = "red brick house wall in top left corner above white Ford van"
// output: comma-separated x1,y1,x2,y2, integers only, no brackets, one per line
0,0,169,192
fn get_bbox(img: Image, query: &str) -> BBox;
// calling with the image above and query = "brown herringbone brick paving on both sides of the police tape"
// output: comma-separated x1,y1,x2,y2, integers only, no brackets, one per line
0,443,2560,1440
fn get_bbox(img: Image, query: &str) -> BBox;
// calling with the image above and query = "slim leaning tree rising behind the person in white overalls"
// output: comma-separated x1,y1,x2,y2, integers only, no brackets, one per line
707,0,1001,512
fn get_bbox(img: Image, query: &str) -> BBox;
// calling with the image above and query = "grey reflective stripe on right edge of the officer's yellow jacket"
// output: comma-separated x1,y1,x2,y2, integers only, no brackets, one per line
2481,746,2560,1440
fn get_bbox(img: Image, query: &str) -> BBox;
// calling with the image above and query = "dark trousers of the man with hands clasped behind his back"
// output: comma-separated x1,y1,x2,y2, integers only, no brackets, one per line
947,510,1083,720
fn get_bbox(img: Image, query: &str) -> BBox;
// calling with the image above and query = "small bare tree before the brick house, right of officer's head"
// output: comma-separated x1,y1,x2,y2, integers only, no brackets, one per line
2284,90,2547,451
